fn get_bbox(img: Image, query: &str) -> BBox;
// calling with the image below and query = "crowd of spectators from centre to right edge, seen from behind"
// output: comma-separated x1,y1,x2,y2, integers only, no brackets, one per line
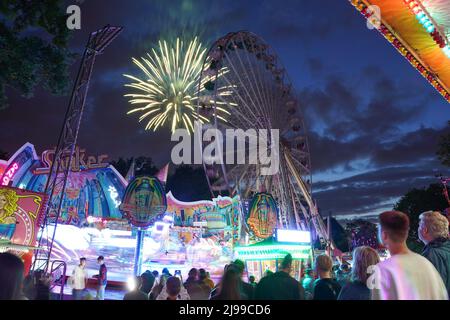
121,211,450,300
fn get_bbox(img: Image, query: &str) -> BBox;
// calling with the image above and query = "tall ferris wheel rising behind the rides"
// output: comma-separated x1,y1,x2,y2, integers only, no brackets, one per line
197,31,326,238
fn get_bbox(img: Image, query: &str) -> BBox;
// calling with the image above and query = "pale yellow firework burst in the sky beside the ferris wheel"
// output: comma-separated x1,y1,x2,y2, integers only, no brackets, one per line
124,38,231,133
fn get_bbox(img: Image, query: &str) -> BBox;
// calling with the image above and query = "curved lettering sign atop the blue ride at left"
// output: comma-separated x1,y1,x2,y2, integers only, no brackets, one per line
33,147,109,174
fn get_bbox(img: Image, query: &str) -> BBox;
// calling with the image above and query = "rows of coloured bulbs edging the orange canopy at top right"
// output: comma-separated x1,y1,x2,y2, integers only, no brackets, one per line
350,0,450,102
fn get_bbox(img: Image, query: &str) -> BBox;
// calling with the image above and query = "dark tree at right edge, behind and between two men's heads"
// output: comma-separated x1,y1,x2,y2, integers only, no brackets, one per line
394,183,448,252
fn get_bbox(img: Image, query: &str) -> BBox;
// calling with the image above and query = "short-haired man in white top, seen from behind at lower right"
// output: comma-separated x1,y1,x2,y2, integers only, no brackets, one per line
368,211,448,300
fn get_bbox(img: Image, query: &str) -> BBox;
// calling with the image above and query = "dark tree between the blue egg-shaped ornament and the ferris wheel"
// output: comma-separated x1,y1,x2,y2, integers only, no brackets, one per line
166,165,211,201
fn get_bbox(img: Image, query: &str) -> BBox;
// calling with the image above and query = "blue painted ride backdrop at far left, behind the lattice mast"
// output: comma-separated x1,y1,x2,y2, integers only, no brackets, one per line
0,143,127,226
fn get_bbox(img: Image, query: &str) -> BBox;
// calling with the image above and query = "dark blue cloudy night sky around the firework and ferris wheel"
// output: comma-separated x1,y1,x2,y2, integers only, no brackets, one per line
0,0,450,219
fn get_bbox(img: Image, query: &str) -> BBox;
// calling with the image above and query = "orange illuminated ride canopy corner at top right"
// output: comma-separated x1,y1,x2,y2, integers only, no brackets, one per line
350,0,450,103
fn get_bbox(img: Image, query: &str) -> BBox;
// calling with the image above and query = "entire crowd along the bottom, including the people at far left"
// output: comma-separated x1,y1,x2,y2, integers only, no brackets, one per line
0,211,450,300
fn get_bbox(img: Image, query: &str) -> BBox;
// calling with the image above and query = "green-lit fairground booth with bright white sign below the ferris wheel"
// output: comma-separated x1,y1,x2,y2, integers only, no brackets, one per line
234,229,312,281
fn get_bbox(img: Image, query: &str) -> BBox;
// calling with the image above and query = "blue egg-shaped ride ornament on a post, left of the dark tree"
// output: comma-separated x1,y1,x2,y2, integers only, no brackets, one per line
119,176,167,228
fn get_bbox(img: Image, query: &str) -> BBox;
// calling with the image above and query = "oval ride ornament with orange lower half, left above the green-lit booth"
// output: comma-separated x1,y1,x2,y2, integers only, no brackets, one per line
247,192,278,239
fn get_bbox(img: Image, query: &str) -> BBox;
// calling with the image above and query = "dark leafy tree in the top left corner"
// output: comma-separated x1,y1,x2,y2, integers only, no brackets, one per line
0,0,75,109
